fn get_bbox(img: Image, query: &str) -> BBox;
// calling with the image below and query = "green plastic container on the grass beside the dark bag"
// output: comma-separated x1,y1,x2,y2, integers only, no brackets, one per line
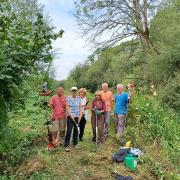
124,154,137,171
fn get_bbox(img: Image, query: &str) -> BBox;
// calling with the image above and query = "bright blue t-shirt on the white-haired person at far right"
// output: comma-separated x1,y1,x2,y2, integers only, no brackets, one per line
114,92,128,115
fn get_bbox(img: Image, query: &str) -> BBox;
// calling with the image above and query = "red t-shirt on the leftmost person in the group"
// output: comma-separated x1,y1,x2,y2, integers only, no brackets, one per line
49,95,66,119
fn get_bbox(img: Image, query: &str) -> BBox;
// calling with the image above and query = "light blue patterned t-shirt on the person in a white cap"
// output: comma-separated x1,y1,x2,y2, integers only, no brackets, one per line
67,96,81,117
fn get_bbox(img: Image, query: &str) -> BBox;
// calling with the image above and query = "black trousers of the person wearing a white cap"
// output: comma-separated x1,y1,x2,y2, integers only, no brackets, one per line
64,116,78,147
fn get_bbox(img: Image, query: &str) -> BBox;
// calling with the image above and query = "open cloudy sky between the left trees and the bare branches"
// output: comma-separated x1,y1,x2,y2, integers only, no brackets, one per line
38,0,90,80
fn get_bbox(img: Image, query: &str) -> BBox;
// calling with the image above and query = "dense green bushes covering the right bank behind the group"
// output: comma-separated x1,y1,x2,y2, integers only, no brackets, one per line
67,0,180,111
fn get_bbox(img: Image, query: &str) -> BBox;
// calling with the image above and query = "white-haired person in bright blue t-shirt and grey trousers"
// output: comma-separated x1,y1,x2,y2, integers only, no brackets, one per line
114,84,128,135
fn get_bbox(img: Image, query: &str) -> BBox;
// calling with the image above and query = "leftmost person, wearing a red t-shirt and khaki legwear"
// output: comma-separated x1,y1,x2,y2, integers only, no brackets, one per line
48,87,66,146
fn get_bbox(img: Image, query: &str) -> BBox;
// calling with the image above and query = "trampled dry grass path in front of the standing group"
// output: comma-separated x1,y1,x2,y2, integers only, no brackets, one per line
14,117,152,180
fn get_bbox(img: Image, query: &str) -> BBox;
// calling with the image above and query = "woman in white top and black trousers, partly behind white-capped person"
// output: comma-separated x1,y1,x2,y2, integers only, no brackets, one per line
79,88,88,141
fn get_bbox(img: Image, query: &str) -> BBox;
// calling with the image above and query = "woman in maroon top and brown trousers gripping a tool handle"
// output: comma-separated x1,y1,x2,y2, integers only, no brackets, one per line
91,91,106,144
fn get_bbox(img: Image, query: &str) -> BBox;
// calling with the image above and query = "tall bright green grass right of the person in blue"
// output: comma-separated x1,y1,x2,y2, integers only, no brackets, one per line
129,94,180,165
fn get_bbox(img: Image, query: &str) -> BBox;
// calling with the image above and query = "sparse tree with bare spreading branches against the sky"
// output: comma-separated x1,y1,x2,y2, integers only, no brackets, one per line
75,0,159,50
